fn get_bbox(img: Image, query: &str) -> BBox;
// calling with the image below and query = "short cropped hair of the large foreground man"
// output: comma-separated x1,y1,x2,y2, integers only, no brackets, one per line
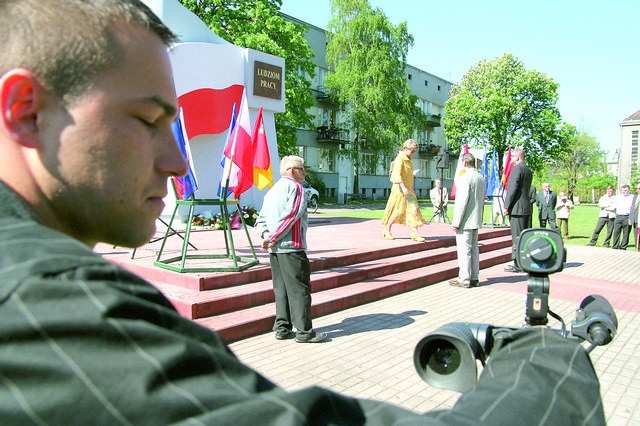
0,0,176,103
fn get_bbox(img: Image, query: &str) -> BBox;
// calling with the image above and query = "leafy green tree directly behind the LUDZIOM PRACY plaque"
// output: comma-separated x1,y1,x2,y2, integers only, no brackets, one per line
180,0,315,156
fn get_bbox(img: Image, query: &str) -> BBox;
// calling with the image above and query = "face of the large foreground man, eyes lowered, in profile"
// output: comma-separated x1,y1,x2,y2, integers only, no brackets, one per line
38,25,187,246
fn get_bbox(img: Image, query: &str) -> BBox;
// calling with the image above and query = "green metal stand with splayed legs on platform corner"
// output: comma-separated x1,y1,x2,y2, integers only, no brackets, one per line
153,191,259,272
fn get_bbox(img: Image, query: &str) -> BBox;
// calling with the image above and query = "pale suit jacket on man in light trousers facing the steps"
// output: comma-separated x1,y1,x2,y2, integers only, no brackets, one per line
451,169,485,229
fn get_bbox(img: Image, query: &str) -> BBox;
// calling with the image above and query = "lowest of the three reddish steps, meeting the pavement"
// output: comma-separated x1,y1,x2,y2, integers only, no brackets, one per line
195,246,511,342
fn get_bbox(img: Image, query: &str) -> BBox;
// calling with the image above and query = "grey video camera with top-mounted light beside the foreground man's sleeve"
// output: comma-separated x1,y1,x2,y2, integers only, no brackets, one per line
413,228,618,392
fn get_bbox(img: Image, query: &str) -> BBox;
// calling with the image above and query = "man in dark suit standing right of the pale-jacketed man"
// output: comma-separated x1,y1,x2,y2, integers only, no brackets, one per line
504,148,533,272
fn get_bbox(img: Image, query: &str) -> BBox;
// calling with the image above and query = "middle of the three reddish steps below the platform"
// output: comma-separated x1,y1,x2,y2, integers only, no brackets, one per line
154,236,511,319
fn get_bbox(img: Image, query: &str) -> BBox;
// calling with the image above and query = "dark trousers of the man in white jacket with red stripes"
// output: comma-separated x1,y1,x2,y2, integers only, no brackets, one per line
269,251,312,336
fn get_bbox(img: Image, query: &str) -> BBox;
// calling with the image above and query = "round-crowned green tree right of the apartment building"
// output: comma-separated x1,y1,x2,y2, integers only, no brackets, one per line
444,53,562,170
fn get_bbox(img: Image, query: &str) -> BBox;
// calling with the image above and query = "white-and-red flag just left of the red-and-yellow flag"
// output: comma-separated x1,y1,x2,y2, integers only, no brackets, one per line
224,91,254,198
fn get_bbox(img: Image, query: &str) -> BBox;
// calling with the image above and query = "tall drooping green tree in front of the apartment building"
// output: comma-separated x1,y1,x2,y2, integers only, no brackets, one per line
324,0,426,193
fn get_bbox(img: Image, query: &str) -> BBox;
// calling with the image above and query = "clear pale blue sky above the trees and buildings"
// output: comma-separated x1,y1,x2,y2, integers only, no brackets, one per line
281,0,640,154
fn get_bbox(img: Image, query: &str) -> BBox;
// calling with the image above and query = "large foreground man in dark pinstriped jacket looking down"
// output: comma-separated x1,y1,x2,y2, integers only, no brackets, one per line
0,0,604,425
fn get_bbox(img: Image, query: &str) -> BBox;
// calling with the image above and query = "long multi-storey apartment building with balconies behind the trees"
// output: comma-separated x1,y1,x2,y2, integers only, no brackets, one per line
282,14,455,203
